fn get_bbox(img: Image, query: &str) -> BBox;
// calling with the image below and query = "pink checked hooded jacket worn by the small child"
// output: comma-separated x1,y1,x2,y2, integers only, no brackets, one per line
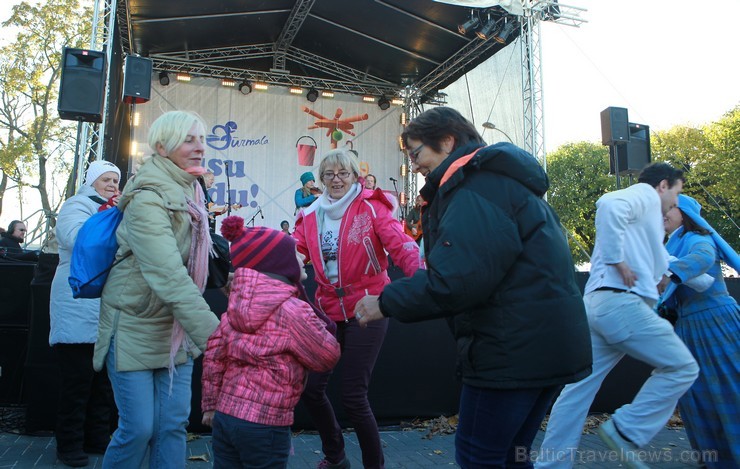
201,268,340,426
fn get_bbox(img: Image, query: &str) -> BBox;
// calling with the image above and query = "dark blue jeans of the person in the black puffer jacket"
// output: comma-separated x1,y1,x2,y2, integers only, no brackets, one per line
455,384,558,469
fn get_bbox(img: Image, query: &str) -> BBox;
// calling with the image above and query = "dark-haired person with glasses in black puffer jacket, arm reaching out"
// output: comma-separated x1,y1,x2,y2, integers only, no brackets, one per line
356,107,591,468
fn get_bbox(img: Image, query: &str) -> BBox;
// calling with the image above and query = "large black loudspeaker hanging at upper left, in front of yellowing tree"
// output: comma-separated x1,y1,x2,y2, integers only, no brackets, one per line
57,47,106,123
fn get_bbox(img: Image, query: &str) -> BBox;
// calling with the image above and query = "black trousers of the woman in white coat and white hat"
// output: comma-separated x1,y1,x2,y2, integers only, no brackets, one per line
54,344,113,453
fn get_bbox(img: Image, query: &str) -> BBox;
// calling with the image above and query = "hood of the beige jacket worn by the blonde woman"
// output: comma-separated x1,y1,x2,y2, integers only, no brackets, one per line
118,155,196,211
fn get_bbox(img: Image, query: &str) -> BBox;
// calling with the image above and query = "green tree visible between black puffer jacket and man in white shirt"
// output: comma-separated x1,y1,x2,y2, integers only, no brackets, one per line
547,142,616,264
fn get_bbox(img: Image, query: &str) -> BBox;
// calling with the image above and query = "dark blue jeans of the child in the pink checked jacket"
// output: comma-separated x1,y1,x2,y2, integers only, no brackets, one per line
213,411,291,469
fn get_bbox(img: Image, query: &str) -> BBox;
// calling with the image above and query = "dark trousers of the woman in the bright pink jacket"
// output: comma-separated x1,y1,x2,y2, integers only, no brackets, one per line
302,319,388,469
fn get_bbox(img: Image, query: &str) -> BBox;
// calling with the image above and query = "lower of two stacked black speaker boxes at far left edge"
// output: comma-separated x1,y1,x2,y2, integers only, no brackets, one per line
0,329,28,404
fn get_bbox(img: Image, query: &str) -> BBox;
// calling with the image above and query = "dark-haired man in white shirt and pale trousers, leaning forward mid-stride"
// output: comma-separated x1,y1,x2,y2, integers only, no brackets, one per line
536,163,699,469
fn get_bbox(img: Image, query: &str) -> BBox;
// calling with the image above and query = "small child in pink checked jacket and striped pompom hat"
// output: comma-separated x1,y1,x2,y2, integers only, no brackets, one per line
201,216,340,468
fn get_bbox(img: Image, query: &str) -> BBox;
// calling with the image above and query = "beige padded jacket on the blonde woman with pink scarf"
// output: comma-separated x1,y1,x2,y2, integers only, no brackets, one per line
93,155,219,371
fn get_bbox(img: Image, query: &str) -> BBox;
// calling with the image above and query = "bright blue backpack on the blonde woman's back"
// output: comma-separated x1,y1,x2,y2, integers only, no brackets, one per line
69,187,157,298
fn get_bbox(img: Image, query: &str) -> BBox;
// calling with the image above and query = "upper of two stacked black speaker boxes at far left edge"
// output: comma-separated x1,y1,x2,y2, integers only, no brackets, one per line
0,262,36,329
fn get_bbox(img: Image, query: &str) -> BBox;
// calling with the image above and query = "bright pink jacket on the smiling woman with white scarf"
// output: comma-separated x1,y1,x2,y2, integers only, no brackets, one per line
293,186,421,321
